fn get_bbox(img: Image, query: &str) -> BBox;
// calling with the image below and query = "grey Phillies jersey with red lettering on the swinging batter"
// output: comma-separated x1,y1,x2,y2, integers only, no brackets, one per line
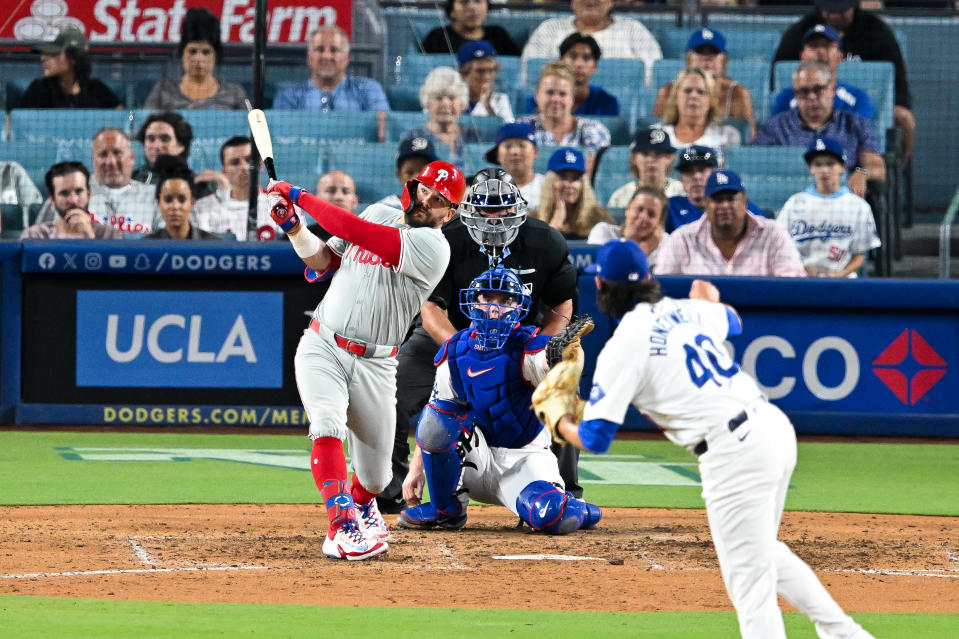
313,204,450,346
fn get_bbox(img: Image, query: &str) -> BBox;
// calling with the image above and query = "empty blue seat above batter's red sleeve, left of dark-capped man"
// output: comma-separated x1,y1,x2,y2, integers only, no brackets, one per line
320,142,399,202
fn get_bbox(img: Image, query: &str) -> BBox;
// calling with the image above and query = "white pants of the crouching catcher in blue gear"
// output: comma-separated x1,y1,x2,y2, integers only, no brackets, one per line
462,426,565,516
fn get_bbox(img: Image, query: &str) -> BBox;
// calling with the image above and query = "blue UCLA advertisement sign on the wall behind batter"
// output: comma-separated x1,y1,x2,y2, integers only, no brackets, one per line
76,291,283,388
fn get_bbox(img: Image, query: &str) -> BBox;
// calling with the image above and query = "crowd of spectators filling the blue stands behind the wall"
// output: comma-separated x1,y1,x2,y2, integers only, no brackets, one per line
0,0,915,277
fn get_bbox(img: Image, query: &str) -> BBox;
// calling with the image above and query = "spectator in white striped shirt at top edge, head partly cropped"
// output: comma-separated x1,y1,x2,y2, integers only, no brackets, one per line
523,0,663,81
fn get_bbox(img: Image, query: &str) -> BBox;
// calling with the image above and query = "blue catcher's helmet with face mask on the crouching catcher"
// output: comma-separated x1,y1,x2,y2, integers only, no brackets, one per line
460,266,530,350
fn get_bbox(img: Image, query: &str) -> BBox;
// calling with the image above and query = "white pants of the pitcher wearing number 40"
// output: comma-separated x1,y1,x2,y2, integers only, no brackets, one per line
699,401,872,639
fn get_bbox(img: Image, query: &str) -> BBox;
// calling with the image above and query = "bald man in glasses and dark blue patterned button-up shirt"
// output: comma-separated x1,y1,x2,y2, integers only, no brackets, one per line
753,60,886,202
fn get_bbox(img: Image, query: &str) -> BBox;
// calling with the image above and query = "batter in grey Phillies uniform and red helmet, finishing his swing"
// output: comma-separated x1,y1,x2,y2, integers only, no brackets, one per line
268,162,466,560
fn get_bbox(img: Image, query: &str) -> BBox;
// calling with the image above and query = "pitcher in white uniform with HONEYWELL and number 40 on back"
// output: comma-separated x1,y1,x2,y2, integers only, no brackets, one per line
533,240,872,639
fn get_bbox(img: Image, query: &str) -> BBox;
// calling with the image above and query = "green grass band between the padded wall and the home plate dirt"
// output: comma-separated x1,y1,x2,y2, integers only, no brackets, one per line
0,431,959,516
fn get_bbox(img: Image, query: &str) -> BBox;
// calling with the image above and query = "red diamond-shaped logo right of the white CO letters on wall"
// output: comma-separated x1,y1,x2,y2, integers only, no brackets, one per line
872,328,947,406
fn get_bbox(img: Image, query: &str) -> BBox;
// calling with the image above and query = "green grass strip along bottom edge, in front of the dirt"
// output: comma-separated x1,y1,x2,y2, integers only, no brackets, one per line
0,596,959,639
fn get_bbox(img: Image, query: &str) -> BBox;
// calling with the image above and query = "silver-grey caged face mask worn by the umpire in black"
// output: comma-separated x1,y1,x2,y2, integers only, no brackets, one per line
459,168,526,249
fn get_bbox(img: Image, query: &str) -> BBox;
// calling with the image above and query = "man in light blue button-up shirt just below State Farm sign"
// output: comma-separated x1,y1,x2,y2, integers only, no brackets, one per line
273,26,390,142
